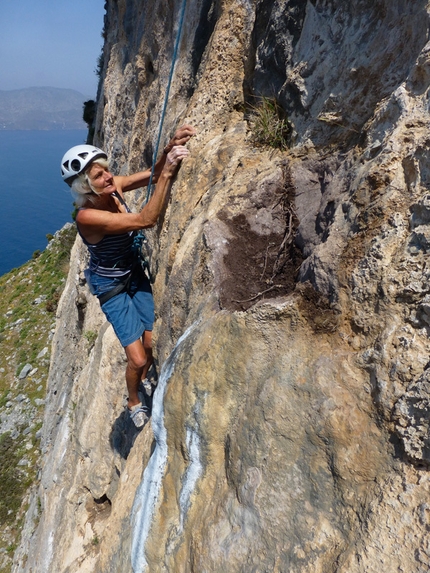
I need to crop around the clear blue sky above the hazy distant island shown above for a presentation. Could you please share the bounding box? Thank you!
[0,0,105,98]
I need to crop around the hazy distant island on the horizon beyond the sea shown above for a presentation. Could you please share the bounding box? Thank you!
[0,87,91,130]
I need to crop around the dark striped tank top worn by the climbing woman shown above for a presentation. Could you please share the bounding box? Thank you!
[76,193,135,278]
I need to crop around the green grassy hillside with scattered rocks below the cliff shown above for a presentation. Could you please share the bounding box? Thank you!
[0,224,76,573]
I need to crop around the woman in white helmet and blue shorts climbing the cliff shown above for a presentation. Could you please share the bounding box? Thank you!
[61,125,195,428]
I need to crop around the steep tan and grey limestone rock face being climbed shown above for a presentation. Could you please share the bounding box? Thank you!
[10,0,430,573]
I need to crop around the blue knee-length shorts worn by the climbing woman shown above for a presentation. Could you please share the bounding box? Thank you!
[91,272,154,347]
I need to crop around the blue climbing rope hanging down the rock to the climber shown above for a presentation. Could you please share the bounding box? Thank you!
[132,0,187,273]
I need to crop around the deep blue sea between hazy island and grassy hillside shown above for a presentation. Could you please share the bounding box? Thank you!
[0,129,87,276]
